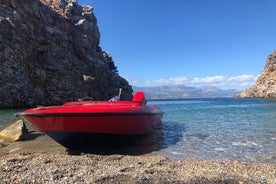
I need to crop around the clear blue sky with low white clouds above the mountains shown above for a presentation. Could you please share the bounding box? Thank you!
[78,0,276,89]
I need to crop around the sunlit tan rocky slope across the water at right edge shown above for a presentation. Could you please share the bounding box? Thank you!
[235,51,276,98]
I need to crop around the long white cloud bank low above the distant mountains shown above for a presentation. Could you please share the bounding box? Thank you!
[146,74,256,89]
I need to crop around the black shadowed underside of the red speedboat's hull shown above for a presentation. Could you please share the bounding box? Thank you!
[46,125,163,155]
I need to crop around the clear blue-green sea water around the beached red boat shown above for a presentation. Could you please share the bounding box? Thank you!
[0,98,276,163]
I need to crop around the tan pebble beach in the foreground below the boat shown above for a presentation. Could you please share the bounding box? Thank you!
[0,152,276,184]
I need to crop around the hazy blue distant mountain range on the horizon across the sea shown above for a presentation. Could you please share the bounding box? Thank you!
[133,85,241,99]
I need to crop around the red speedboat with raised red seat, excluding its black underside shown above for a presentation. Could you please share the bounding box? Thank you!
[17,92,163,145]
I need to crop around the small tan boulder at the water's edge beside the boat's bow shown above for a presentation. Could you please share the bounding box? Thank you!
[0,120,28,142]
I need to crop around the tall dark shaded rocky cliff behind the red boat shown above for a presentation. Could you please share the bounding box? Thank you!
[0,0,132,108]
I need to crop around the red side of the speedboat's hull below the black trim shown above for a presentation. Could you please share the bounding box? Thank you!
[24,109,162,134]
